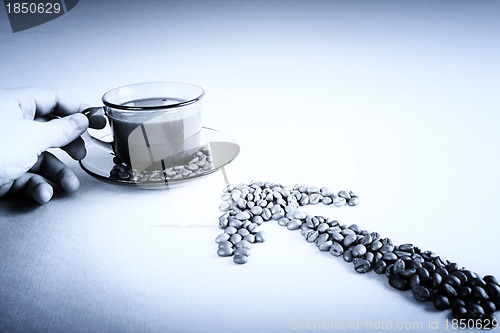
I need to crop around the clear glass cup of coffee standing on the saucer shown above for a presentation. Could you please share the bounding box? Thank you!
[88,82,204,171]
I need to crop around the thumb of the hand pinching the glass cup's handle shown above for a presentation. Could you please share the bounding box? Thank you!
[33,113,89,153]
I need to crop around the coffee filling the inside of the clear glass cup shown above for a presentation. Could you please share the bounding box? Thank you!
[109,98,201,170]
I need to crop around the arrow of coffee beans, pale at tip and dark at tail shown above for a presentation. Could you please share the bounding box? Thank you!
[215,182,500,322]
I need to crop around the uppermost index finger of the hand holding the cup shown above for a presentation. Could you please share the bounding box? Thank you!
[8,88,88,119]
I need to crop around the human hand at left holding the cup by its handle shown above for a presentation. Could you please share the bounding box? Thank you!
[0,88,105,204]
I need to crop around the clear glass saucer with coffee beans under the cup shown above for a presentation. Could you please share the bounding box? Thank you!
[80,127,240,189]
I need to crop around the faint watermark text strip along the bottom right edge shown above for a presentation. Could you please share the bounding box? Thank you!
[289,318,498,332]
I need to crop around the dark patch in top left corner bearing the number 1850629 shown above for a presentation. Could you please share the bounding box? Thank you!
[4,0,79,32]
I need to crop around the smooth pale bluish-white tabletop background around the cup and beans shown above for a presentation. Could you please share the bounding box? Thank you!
[0,1,500,332]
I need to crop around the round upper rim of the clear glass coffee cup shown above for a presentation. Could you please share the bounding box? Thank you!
[102,81,205,111]
